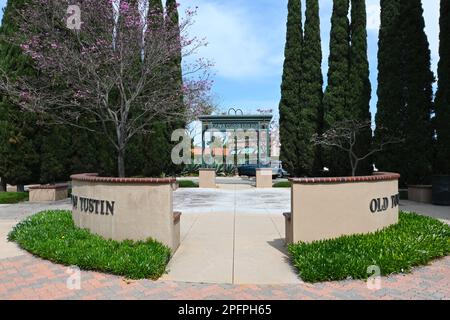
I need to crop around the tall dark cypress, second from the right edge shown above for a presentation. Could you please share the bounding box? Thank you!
[399,0,434,184]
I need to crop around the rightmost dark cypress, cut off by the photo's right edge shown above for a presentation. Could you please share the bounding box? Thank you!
[434,0,450,174]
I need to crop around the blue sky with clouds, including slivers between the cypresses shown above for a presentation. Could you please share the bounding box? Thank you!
[0,0,439,120]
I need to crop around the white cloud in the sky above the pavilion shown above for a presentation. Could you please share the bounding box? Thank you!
[179,0,284,80]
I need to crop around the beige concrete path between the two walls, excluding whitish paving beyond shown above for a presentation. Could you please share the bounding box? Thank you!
[163,212,300,284]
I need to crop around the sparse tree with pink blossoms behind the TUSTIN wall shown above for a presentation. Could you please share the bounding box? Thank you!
[0,0,211,177]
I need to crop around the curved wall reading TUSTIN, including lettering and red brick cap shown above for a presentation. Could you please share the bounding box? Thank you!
[71,174,181,253]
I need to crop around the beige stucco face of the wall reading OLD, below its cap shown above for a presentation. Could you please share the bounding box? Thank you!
[286,180,399,243]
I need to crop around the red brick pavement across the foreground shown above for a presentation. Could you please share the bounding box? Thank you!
[0,254,450,300]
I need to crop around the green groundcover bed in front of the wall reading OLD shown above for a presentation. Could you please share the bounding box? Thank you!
[289,212,450,282]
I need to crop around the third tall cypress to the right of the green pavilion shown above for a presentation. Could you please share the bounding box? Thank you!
[323,0,352,175]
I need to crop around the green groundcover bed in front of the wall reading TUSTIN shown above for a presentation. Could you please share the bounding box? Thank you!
[8,211,170,280]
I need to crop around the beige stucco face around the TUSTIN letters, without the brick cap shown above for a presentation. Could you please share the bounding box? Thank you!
[72,180,180,252]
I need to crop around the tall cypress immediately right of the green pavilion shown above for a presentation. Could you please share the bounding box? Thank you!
[279,0,303,175]
